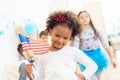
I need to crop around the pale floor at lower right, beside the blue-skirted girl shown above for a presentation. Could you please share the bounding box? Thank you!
[102,51,120,80]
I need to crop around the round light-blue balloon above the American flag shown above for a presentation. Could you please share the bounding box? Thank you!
[25,23,37,35]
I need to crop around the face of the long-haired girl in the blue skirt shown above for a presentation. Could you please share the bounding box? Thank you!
[79,12,90,25]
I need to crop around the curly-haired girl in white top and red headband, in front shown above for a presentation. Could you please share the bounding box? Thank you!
[24,11,97,80]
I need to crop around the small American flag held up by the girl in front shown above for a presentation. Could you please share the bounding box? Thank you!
[18,34,49,55]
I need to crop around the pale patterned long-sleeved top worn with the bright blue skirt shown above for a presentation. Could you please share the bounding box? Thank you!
[74,27,109,51]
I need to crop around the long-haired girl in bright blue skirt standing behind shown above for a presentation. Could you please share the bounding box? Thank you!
[73,11,116,80]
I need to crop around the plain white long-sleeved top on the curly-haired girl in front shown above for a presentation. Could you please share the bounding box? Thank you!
[41,46,97,80]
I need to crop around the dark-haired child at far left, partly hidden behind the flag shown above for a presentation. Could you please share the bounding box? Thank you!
[17,44,38,80]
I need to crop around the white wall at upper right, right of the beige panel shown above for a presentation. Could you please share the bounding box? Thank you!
[101,0,120,34]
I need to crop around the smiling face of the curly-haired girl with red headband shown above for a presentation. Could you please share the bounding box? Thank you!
[50,25,72,51]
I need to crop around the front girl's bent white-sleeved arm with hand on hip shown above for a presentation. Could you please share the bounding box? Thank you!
[73,48,98,80]
